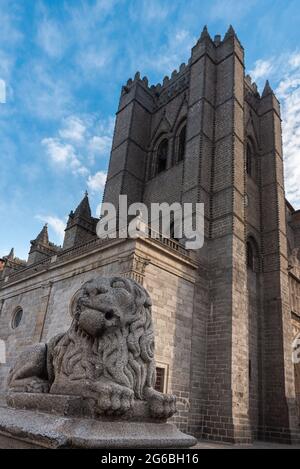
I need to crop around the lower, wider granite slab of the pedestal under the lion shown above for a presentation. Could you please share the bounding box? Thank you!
[0,407,197,449]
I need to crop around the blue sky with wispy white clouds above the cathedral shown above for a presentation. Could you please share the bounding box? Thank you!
[0,0,300,258]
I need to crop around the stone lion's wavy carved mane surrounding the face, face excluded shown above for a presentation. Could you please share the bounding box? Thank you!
[48,279,155,399]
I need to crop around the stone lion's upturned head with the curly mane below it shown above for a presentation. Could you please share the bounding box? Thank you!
[67,277,155,399]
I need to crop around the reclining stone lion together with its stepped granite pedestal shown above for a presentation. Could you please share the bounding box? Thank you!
[0,277,196,448]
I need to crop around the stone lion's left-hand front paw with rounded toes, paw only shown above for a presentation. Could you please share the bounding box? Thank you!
[97,386,134,415]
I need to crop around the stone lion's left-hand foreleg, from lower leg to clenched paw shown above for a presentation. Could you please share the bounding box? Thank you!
[88,380,134,415]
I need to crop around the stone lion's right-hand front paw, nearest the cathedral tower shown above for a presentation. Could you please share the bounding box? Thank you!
[145,387,176,419]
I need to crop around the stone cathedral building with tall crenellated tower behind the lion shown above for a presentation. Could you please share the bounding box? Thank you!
[0,27,300,443]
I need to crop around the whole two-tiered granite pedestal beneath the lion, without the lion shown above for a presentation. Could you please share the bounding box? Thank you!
[0,393,197,449]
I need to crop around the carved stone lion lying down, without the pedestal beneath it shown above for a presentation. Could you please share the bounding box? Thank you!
[8,277,176,419]
